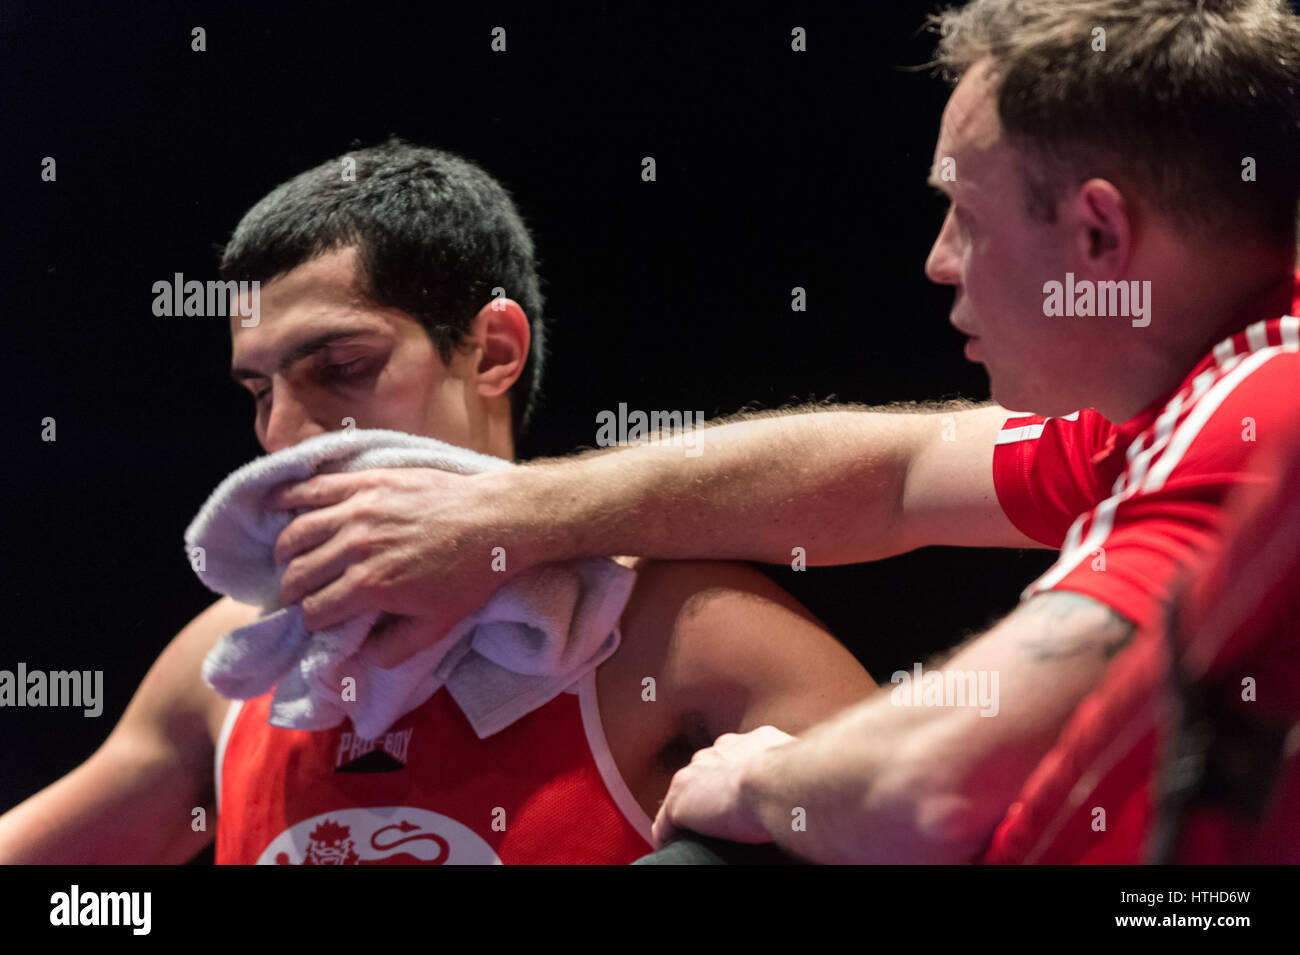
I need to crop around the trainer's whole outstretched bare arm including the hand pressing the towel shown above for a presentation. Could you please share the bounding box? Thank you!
[273,403,1039,667]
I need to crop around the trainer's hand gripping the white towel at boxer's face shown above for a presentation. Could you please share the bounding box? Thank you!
[268,468,530,668]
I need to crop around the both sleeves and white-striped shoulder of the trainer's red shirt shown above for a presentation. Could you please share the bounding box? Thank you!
[993,310,1300,626]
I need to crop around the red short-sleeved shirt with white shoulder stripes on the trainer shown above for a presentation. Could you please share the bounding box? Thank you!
[982,277,1300,864]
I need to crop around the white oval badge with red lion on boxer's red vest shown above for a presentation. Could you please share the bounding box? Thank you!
[257,806,502,865]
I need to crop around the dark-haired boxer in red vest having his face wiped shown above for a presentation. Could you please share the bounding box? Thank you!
[0,140,875,864]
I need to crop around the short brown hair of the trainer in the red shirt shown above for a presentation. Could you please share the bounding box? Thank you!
[930,0,1300,243]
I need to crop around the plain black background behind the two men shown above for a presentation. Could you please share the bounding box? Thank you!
[0,0,1052,857]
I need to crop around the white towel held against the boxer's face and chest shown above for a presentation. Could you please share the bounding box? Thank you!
[185,430,636,738]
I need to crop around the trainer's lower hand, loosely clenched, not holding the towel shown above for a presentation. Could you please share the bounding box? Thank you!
[650,726,794,847]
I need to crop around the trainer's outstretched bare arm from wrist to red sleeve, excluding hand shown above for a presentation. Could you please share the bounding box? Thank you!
[522,403,1041,565]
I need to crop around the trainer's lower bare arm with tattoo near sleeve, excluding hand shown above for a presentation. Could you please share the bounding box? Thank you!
[742,591,1134,863]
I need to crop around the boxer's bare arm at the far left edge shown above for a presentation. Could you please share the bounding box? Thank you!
[0,599,256,865]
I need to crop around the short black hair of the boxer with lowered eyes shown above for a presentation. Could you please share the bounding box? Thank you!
[220,138,546,440]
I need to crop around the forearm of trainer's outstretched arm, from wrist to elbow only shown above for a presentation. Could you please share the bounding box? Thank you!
[502,411,937,565]
